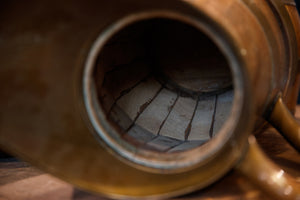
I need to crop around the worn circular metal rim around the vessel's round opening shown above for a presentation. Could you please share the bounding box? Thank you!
[83,11,245,173]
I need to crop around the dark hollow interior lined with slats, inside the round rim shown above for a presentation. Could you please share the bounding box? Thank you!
[94,18,234,152]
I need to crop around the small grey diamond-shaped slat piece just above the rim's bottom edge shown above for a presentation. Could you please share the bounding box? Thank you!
[145,135,182,151]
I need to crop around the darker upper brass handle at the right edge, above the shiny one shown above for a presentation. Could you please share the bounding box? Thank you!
[268,97,300,151]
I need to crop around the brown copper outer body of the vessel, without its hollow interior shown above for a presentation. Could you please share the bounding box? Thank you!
[0,0,300,199]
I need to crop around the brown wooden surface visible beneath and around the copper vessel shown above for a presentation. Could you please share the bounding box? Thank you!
[0,107,300,200]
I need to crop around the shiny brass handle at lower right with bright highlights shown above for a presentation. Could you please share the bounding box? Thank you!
[236,136,300,200]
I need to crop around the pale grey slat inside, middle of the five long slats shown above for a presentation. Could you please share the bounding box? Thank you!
[159,97,196,140]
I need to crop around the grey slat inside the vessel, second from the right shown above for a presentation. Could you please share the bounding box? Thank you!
[188,96,216,140]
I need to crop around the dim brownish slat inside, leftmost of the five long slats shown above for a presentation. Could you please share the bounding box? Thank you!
[116,78,161,120]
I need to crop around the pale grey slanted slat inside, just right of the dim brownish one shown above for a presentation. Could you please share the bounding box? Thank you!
[136,89,177,134]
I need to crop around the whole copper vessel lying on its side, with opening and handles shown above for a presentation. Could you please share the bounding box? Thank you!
[0,0,300,199]
